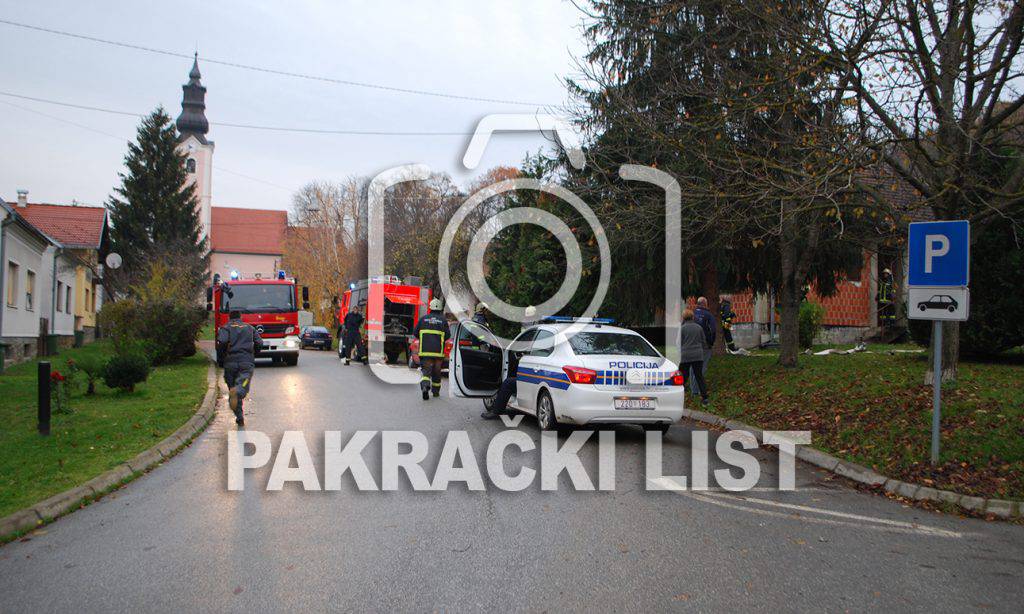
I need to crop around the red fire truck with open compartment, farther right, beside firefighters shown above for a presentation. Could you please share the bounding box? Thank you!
[338,275,431,362]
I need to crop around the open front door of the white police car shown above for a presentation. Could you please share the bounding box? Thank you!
[449,320,505,397]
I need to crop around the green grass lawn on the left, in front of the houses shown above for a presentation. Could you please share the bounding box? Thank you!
[0,341,207,517]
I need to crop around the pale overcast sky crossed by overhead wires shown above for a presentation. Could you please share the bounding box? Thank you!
[0,0,586,209]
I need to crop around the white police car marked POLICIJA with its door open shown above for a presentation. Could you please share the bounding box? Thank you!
[449,317,684,433]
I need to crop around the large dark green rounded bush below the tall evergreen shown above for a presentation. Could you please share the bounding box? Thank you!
[99,299,207,364]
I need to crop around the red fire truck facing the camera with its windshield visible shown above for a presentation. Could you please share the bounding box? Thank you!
[206,271,309,366]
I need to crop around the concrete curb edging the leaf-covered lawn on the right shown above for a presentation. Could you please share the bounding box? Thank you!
[683,407,1024,519]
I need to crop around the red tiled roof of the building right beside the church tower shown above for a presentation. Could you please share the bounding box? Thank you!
[210,207,288,256]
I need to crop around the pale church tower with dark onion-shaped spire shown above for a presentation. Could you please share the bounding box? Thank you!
[176,53,213,238]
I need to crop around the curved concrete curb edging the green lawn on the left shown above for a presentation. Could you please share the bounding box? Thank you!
[0,350,219,544]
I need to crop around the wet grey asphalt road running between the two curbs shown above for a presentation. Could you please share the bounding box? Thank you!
[0,343,1024,613]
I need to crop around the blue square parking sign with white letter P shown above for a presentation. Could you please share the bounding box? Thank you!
[907,220,971,287]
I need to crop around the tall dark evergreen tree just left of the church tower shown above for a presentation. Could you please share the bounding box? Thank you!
[106,106,210,293]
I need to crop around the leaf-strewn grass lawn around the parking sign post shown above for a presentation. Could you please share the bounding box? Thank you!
[708,346,1024,499]
